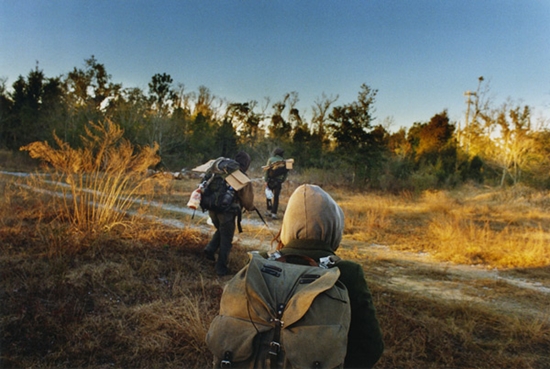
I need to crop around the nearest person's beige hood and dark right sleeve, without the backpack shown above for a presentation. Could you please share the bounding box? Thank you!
[278,184,384,368]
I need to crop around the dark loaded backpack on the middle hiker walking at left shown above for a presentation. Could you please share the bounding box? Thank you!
[200,158,239,212]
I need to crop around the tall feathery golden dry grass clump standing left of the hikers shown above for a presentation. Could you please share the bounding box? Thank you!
[21,120,168,232]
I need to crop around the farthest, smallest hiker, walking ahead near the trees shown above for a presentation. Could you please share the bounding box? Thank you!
[264,147,288,219]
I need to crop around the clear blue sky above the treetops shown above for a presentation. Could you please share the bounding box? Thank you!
[0,0,550,131]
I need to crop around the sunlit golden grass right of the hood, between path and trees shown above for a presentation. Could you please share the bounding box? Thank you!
[338,187,550,268]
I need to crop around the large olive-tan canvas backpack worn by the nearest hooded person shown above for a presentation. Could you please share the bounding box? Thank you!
[206,253,351,368]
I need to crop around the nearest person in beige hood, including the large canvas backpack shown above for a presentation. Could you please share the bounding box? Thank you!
[209,185,384,368]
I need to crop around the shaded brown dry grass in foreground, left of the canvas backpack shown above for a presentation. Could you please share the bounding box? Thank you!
[0,183,222,368]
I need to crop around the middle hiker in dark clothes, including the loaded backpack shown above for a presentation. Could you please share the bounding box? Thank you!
[201,151,256,277]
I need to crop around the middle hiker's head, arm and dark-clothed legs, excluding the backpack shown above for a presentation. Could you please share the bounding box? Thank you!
[204,151,256,277]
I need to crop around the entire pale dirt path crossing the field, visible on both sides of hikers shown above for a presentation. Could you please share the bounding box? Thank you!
[3,172,550,320]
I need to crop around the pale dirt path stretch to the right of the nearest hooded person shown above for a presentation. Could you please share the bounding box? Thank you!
[338,241,550,320]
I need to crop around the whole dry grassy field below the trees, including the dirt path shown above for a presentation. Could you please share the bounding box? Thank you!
[0,168,550,368]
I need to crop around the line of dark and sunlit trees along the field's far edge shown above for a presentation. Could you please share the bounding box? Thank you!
[0,56,550,191]
